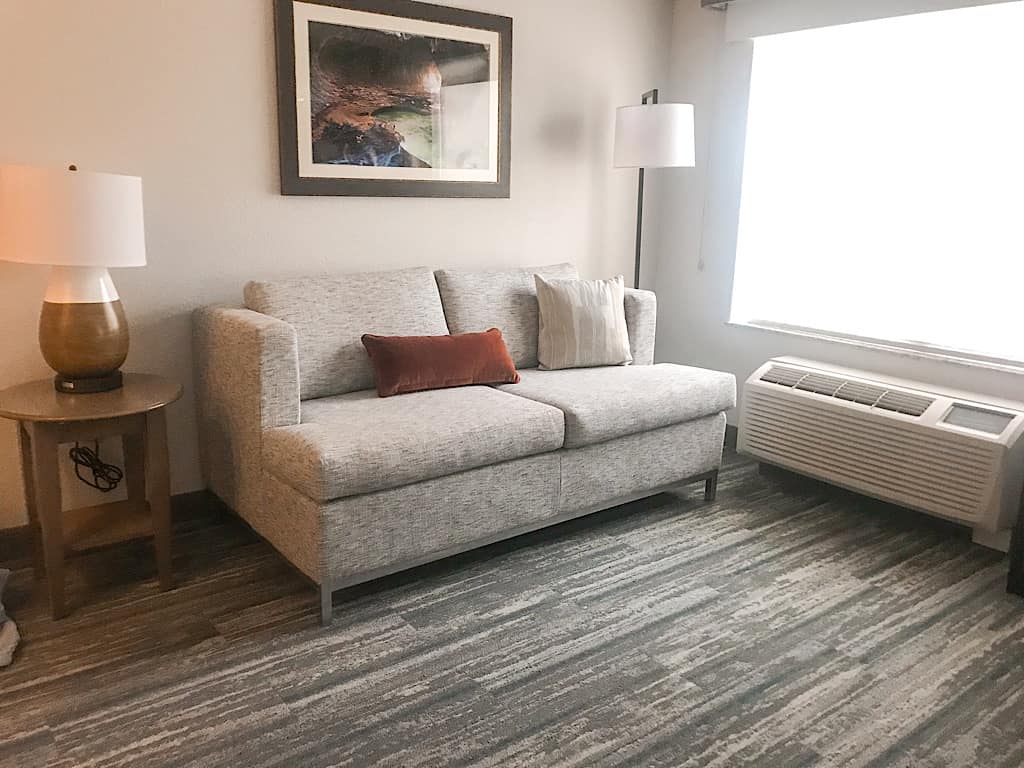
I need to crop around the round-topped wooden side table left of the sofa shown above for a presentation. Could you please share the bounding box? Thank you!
[0,374,181,618]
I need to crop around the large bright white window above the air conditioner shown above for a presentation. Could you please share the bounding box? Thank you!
[732,2,1024,361]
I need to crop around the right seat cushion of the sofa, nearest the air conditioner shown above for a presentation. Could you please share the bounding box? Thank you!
[499,364,736,447]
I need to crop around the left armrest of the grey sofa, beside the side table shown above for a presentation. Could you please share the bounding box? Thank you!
[193,307,301,517]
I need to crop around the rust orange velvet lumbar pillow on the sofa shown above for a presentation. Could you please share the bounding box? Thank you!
[362,328,519,397]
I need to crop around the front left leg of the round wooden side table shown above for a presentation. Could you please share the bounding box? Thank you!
[32,423,68,618]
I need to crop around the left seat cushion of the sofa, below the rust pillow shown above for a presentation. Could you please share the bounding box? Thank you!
[263,387,565,504]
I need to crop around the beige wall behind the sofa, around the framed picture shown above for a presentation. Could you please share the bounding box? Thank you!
[0,0,673,527]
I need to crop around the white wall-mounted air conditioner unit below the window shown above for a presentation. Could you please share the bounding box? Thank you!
[737,357,1024,550]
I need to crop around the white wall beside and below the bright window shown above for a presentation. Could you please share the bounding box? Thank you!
[655,0,1024,420]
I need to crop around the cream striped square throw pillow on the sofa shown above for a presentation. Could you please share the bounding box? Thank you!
[534,274,633,371]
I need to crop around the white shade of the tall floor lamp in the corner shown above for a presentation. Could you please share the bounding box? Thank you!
[615,104,695,168]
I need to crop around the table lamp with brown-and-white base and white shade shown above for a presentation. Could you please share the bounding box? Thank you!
[0,165,145,394]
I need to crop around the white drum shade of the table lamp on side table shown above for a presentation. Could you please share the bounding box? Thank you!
[0,165,145,267]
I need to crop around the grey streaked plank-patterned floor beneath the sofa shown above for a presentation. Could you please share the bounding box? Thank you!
[0,456,1024,768]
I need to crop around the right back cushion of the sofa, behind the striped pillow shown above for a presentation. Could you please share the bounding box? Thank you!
[435,264,580,368]
